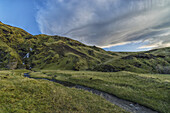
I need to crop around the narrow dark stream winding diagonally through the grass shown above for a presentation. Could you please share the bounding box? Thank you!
[24,73,158,113]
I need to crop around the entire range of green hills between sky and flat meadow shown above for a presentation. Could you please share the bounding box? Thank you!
[0,22,170,73]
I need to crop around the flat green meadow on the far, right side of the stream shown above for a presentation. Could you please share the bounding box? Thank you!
[31,70,170,113]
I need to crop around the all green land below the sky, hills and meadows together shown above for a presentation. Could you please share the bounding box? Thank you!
[0,22,170,113]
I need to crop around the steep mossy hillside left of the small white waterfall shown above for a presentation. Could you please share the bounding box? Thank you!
[0,22,31,69]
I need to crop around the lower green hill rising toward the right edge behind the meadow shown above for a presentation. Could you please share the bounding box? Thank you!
[94,48,170,74]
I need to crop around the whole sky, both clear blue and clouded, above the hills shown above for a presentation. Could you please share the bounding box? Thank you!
[0,0,170,51]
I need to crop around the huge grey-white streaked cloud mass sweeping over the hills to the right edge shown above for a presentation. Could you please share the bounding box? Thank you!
[37,0,170,48]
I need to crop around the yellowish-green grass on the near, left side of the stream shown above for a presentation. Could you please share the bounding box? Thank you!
[0,70,125,113]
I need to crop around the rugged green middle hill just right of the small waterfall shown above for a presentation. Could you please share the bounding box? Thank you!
[29,35,112,70]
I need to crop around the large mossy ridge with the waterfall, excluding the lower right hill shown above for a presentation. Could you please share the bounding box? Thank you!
[0,23,113,70]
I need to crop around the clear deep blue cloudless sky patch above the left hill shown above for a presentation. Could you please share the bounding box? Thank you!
[0,0,41,34]
